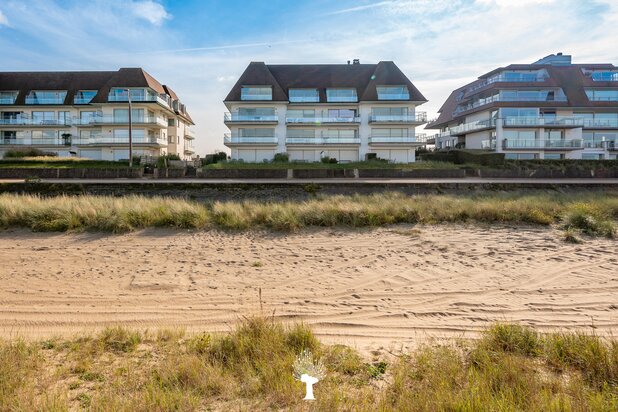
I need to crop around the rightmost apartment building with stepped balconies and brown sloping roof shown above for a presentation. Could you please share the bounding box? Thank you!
[427,53,618,159]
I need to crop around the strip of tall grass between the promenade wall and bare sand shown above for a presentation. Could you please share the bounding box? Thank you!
[0,192,618,237]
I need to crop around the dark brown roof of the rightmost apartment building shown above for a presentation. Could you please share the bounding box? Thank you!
[426,64,618,129]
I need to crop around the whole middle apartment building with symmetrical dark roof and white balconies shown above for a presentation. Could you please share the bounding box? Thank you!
[224,60,427,163]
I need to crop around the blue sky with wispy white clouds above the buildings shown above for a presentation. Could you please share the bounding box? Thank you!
[0,0,618,156]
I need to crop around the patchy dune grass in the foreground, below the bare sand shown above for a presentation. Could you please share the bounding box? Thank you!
[0,317,618,411]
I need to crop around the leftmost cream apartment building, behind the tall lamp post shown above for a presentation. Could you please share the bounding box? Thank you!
[0,68,195,160]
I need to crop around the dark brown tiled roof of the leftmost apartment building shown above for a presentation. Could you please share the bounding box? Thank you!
[0,68,191,120]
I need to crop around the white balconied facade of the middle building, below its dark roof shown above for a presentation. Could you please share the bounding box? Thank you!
[224,101,426,163]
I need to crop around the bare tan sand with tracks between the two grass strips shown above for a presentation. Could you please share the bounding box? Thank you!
[0,225,618,350]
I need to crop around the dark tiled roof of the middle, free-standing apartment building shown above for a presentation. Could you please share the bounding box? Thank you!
[225,61,427,102]
